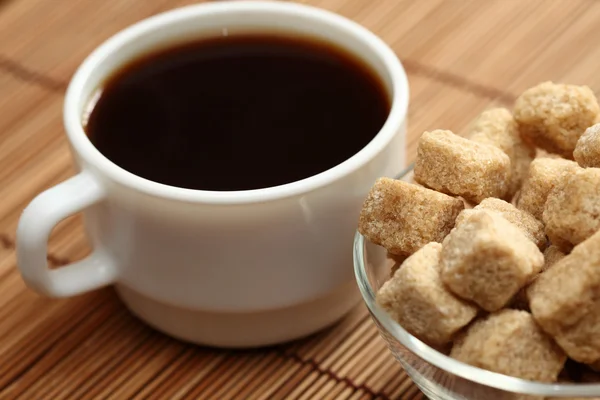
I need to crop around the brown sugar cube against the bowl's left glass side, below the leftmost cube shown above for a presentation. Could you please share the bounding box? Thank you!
[377,242,477,346]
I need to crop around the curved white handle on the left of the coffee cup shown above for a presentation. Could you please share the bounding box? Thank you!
[17,172,117,297]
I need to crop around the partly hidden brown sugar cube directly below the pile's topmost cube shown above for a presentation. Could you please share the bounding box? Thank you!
[517,158,579,221]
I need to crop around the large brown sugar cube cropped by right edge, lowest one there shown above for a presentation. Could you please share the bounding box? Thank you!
[527,227,600,364]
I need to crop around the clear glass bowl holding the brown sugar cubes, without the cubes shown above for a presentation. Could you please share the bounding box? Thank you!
[354,166,600,400]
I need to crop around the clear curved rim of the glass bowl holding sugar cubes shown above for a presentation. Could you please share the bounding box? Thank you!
[353,164,600,397]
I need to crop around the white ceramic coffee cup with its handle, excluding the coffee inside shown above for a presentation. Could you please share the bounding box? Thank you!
[17,1,408,347]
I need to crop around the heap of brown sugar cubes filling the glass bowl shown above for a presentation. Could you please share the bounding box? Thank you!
[359,82,600,388]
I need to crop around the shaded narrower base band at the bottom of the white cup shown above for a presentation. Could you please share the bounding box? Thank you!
[116,282,360,348]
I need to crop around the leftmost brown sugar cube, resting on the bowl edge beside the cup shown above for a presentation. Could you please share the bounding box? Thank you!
[358,178,464,255]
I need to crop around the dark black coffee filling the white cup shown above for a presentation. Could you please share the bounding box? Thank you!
[85,34,390,191]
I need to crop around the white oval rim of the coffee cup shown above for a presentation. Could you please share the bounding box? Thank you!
[63,0,409,204]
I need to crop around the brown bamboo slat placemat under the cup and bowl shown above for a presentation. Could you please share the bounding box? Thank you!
[0,0,600,400]
